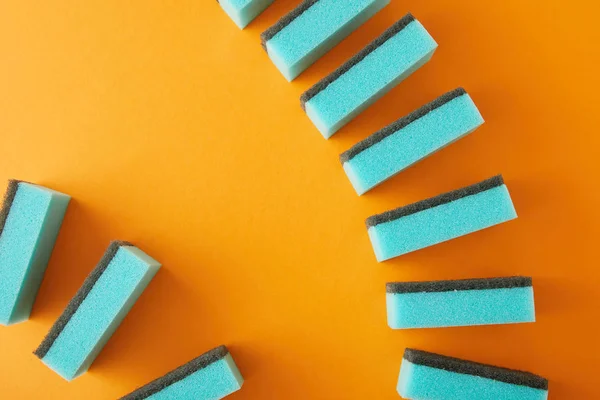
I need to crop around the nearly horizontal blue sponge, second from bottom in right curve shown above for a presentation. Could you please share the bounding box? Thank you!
[386,276,535,329]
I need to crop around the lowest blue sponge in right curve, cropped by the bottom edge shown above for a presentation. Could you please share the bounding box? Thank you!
[397,349,548,400]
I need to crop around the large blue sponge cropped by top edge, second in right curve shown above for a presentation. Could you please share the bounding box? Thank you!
[261,0,390,81]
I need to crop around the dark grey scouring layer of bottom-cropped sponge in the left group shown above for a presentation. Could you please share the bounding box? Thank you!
[120,346,229,400]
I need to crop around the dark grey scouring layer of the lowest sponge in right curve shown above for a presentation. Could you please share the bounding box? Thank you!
[404,349,548,390]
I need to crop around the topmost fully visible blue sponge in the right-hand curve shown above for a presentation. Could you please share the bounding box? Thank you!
[300,14,437,139]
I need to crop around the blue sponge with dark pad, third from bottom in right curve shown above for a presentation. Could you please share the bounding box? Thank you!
[366,175,517,261]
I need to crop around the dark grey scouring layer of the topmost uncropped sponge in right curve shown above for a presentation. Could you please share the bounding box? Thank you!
[300,13,415,110]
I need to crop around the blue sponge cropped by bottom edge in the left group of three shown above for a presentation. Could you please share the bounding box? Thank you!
[121,346,244,400]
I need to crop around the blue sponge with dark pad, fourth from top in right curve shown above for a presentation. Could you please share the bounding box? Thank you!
[340,88,483,195]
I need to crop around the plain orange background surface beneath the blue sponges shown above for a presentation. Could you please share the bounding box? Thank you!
[0,0,600,399]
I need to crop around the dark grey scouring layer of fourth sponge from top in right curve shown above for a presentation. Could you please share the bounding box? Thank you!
[340,88,467,164]
